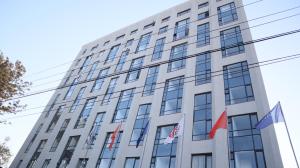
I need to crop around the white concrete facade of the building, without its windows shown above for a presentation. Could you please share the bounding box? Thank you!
[11,0,284,168]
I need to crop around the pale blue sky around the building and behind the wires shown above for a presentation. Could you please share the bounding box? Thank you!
[0,0,300,165]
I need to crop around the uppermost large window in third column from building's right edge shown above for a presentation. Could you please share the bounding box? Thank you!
[173,18,190,40]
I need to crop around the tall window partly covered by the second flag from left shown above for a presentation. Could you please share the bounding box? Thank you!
[129,103,151,145]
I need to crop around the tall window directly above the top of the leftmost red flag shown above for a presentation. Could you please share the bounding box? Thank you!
[112,89,134,123]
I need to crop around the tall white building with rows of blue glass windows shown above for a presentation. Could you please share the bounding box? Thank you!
[11,0,283,168]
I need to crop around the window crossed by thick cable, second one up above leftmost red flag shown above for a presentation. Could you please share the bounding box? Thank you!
[125,57,144,83]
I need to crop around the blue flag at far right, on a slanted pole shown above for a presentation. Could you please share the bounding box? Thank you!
[256,102,284,130]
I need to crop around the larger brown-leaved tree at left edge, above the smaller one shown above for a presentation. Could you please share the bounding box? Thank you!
[0,52,31,114]
